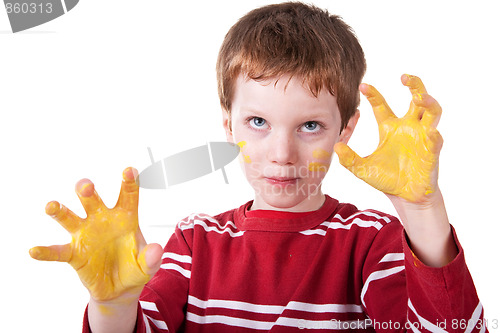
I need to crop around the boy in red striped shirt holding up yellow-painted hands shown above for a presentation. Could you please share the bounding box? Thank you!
[30,3,485,332]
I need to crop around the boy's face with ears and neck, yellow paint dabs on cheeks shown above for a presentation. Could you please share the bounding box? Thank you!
[223,75,359,211]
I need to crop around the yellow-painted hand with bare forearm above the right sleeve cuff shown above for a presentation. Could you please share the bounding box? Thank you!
[335,75,457,267]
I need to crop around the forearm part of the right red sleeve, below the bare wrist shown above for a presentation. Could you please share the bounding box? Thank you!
[403,227,487,332]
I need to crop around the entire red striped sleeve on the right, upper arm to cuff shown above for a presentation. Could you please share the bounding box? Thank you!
[361,221,487,332]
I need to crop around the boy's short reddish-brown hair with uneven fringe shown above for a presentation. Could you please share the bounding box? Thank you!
[217,2,366,131]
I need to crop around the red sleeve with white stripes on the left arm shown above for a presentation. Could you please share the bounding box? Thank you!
[83,222,192,333]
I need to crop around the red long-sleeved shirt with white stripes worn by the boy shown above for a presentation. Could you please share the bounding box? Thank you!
[84,196,484,333]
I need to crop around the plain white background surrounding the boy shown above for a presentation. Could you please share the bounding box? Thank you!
[0,0,500,332]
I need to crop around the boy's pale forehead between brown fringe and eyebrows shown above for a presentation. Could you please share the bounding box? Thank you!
[232,74,340,118]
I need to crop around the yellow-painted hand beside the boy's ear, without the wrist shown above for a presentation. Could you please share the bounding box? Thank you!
[335,75,443,202]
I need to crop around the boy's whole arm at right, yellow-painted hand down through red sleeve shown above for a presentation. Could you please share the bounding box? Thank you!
[335,75,484,332]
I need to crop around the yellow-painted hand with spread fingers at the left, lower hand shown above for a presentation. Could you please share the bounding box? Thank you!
[30,168,163,302]
